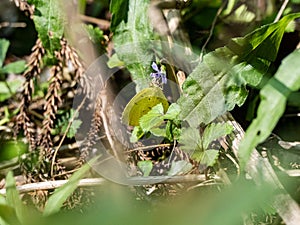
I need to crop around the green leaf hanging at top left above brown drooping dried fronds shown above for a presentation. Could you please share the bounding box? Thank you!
[32,0,64,57]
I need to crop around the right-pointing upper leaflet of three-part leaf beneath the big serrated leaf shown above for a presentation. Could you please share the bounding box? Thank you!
[202,123,233,149]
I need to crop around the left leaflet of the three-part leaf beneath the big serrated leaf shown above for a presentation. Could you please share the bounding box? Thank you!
[178,127,203,152]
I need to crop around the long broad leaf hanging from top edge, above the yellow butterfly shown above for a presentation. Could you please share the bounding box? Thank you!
[114,0,154,91]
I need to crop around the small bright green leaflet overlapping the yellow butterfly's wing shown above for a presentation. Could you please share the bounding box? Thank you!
[140,103,164,132]
